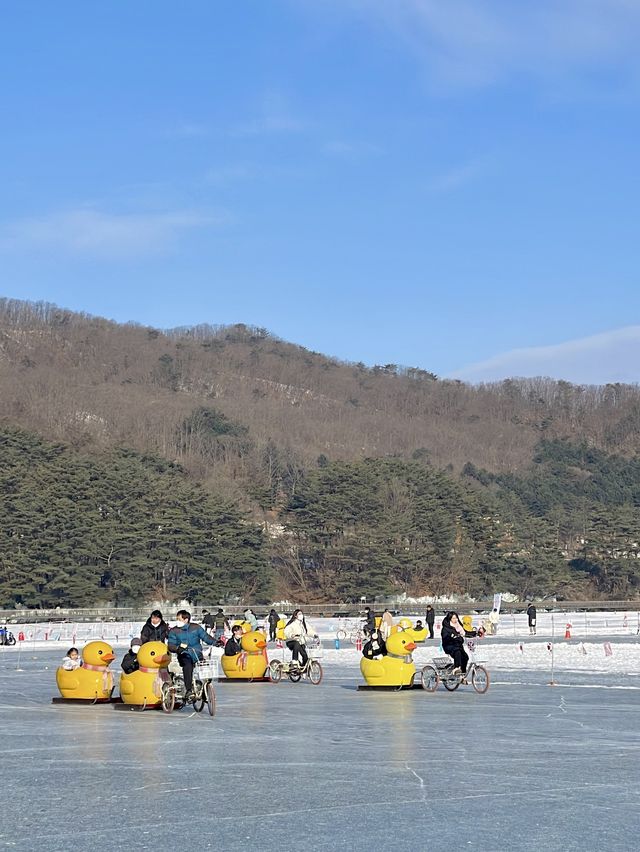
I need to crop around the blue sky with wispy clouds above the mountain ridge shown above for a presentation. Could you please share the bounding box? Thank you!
[0,0,640,383]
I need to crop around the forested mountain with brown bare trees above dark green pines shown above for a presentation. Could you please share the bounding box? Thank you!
[0,300,640,604]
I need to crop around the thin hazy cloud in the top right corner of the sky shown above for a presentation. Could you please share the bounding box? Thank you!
[332,0,640,88]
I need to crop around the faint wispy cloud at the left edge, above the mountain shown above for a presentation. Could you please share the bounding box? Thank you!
[0,207,226,258]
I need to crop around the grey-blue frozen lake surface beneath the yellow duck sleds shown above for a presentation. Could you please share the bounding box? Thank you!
[0,647,640,852]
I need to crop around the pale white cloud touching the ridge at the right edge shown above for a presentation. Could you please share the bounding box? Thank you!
[449,325,640,385]
